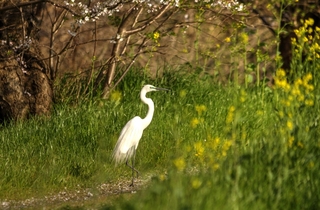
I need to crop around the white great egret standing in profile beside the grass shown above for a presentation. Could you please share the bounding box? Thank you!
[112,85,168,186]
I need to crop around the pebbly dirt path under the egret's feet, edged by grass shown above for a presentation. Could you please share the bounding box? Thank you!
[0,177,150,210]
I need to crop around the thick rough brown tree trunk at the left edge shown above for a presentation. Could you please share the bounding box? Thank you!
[0,1,53,123]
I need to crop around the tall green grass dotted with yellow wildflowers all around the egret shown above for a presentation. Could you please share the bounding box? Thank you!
[0,65,320,209]
